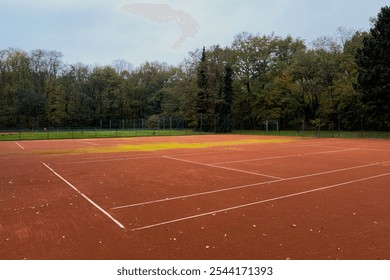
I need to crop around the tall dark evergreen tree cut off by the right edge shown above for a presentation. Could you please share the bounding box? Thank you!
[355,6,390,130]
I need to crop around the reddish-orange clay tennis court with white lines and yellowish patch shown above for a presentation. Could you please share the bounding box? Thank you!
[0,135,390,260]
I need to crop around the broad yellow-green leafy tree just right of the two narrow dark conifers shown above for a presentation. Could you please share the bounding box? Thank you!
[232,33,306,129]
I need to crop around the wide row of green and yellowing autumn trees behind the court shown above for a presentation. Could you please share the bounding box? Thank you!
[0,8,390,131]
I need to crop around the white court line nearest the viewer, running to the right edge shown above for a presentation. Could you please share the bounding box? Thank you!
[131,173,390,231]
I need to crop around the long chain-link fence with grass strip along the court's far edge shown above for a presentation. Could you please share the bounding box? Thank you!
[0,114,390,141]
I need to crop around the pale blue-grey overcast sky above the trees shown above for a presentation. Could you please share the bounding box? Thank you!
[0,0,389,66]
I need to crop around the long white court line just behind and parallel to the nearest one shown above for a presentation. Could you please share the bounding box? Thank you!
[111,161,390,210]
